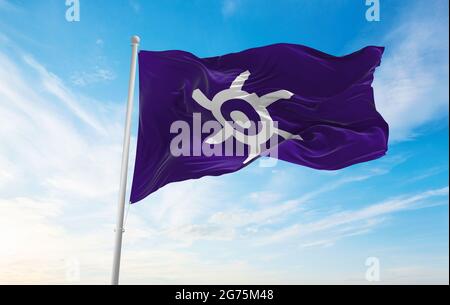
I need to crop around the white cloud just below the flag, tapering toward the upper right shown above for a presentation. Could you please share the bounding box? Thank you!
[137,152,406,245]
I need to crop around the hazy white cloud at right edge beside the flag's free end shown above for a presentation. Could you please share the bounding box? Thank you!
[374,1,449,142]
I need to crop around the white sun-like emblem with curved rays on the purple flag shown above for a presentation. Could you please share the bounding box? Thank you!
[192,71,301,164]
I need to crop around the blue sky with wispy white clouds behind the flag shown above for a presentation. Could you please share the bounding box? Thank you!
[0,0,449,284]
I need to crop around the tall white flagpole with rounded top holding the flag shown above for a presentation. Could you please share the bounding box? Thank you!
[111,36,140,285]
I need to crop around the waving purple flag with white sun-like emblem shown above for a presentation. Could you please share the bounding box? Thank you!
[131,44,389,203]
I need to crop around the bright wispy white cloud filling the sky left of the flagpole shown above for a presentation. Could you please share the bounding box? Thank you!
[0,40,126,283]
